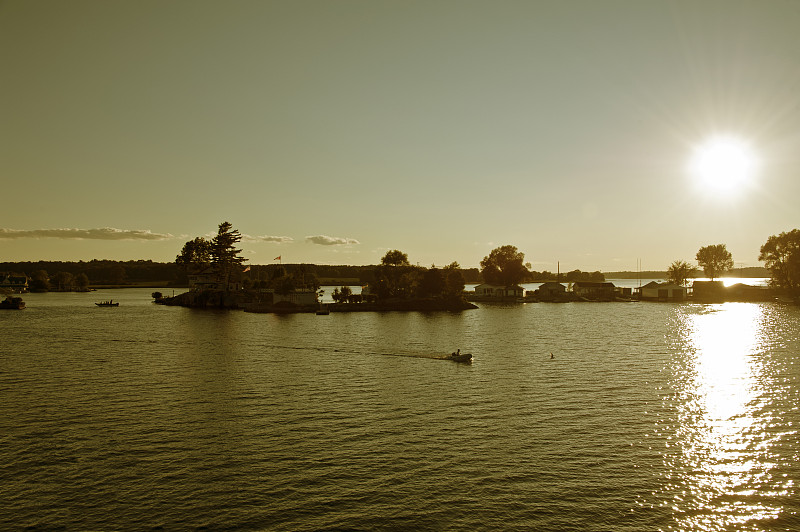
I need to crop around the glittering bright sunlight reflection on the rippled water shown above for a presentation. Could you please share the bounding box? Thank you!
[665,303,794,530]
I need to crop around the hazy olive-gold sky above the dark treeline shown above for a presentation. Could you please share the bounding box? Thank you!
[0,0,800,271]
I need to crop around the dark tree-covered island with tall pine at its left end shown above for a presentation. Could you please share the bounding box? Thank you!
[163,222,478,315]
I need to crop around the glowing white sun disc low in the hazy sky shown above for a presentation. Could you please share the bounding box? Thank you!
[689,135,758,194]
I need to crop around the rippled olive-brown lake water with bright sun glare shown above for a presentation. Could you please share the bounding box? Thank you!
[0,289,800,531]
